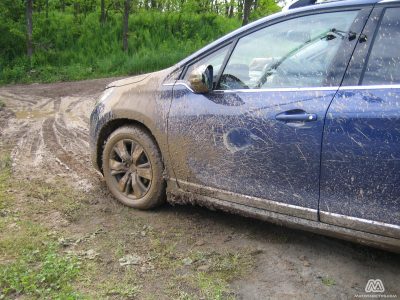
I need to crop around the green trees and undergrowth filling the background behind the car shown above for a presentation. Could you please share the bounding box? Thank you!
[0,0,279,84]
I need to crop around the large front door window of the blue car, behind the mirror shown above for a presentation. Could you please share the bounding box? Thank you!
[218,11,358,90]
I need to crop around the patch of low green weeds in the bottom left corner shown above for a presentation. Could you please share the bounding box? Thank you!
[0,246,80,299]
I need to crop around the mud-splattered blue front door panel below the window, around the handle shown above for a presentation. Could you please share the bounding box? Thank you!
[169,85,336,208]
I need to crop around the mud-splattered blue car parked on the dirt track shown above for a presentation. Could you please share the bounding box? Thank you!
[90,0,400,252]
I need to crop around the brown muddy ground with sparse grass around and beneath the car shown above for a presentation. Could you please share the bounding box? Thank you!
[0,79,400,299]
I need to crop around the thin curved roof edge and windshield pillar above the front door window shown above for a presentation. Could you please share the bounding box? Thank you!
[177,0,390,66]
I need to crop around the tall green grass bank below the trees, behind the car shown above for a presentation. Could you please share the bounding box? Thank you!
[0,11,240,84]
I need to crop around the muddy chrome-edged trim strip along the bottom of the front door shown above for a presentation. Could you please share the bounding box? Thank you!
[177,180,318,221]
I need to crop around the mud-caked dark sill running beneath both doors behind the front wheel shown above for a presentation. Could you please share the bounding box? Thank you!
[167,187,400,253]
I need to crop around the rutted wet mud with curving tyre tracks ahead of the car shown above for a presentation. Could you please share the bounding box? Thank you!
[0,81,111,186]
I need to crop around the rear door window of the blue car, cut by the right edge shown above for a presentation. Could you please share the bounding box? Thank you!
[362,8,400,85]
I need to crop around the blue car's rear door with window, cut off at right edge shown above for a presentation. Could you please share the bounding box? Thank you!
[320,2,400,238]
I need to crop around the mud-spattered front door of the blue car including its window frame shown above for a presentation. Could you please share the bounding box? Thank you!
[168,8,369,220]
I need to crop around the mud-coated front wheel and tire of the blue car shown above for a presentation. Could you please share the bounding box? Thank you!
[102,126,165,209]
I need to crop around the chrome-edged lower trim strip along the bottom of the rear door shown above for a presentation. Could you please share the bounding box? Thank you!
[320,211,400,239]
